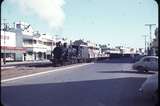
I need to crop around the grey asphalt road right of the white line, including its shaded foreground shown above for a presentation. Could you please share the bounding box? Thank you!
[1,62,154,106]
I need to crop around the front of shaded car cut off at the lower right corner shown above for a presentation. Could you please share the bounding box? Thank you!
[139,73,158,104]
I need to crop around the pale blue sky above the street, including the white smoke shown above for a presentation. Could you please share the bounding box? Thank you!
[1,0,158,48]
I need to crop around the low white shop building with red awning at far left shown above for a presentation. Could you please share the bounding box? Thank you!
[1,31,25,61]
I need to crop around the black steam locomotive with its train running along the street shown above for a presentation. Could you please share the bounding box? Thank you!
[50,44,101,66]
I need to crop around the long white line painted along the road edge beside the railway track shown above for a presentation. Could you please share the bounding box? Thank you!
[1,63,93,83]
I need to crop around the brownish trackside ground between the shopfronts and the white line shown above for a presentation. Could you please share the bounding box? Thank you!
[1,60,54,80]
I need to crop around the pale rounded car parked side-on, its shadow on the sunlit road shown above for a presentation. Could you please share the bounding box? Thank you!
[132,56,158,72]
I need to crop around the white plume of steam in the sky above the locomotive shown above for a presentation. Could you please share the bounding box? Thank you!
[12,0,65,28]
